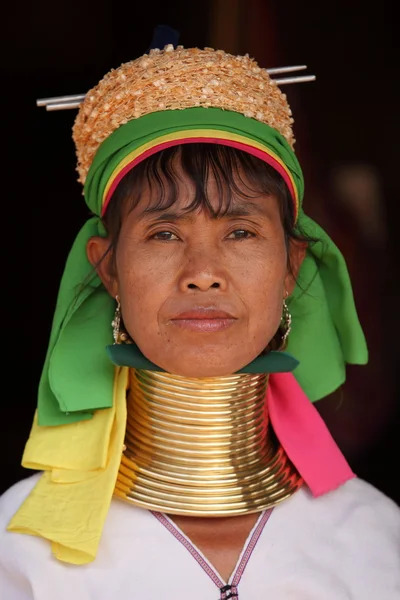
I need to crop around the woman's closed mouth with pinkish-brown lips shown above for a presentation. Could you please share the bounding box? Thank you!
[171,307,237,333]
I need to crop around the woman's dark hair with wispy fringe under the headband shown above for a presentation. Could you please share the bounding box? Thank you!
[103,143,315,276]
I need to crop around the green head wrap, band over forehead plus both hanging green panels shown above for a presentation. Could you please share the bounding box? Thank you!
[38,108,367,425]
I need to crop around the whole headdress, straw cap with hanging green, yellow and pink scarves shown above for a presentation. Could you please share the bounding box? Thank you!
[5,46,367,564]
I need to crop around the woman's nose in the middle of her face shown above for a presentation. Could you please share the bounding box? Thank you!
[179,254,227,292]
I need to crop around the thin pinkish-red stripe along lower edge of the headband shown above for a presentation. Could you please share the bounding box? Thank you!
[101,137,298,221]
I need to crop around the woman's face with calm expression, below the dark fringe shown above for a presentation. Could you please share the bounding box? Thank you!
[88,166,304,377]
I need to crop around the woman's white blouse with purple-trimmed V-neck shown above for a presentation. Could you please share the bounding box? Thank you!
[0,475,400,600]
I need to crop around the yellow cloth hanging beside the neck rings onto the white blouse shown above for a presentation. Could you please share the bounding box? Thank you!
[8,367,128,565]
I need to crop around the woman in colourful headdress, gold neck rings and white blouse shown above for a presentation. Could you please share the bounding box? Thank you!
[0,46,400,600]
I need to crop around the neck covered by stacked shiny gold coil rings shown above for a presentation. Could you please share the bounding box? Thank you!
[115,369,302,516]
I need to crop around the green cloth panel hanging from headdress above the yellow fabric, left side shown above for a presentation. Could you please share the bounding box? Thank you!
[38,217,114,425]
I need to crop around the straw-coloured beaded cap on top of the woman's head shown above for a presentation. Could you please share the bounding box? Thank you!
[73,45,294,184]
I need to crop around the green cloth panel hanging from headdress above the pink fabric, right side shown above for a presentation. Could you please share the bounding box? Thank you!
[287,212,368,401]
